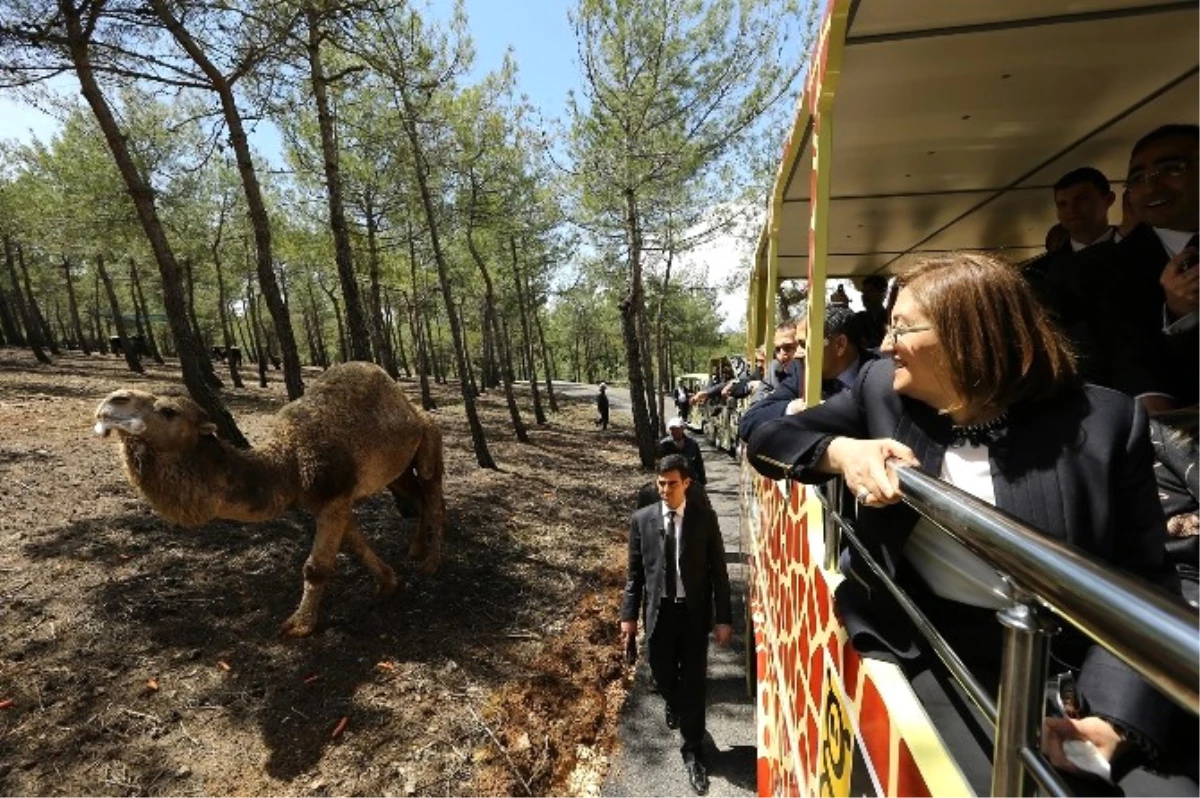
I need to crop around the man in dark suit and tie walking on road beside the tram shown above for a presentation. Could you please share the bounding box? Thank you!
[620,455,733,796]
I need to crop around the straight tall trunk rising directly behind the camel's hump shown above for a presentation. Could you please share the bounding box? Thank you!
[305,4,369,360]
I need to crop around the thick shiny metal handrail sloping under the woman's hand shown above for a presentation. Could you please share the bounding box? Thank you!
[895,464,1200,714]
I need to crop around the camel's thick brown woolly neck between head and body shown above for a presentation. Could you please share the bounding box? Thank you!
[124,437,298,527]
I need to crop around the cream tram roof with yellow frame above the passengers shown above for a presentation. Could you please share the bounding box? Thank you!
[758,0,1200,280]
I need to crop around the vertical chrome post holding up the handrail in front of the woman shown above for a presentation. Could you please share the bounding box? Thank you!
[991,602,1058,798]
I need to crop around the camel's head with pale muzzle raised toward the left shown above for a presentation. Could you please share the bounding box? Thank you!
[95,389,217,451]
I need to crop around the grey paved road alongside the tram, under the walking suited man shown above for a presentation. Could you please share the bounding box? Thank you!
[600,432,756,798]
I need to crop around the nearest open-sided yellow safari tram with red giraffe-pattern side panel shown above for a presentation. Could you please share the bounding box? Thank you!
[742,0,1200,798]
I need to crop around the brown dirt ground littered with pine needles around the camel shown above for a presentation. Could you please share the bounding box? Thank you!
[0,349,646,796]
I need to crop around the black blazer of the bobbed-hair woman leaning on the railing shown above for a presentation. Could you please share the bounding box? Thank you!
[748,360,1176,742]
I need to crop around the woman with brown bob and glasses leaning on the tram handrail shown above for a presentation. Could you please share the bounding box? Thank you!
[748,254,1176,775]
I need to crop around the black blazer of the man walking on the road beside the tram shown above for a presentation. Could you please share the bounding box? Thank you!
[620,502,733,640]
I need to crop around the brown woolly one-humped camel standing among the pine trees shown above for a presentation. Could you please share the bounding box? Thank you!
[95,362,445,637]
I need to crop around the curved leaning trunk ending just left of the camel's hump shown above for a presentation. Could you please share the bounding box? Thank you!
[150,0,304,400]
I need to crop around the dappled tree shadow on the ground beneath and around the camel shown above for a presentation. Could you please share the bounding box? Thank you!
[8,498,549,780]
